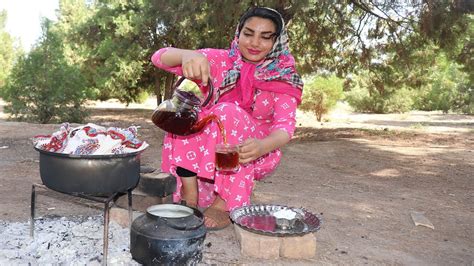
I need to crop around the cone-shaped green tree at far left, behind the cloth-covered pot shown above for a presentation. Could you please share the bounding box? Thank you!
[2,20,90,123]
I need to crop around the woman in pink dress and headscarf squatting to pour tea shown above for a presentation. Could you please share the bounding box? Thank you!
[152,7,303,230]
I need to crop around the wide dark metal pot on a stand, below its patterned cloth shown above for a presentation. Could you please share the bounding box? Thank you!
[35,147,140,196]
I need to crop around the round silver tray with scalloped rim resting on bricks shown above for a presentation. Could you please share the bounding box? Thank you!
[230,205,322,236]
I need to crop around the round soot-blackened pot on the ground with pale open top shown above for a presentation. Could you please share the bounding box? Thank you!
[130,204,206,265]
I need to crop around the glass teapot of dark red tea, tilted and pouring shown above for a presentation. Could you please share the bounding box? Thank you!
[151,77,214,136]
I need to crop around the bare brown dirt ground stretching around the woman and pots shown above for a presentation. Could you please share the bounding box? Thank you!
[0,98,474,265]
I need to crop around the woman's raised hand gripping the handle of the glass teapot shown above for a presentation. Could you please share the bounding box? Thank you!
[181,51,210,86]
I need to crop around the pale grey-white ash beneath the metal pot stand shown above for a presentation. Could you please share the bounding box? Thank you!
[0,216,140,265]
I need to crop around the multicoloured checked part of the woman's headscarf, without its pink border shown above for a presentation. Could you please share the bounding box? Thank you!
[220,8,303,101]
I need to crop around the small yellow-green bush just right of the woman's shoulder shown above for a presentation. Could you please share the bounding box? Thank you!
[299,75,344,121]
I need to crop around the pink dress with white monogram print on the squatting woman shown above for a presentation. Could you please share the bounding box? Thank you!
[152,48,297,211]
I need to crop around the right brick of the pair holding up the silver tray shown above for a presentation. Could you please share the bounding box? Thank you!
[280,233,316,259]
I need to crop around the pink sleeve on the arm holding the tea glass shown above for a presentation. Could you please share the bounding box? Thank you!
[270,93,298,138]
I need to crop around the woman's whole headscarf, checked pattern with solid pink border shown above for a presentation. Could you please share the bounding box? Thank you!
[219,9,303,108]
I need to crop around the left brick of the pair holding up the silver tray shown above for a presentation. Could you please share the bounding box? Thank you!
[234,225,280,259]
